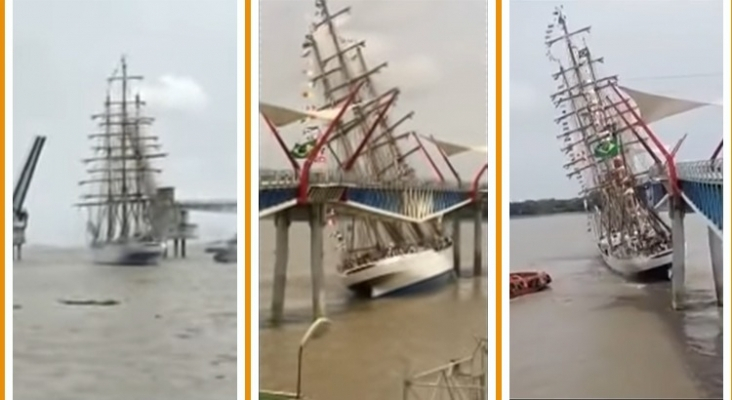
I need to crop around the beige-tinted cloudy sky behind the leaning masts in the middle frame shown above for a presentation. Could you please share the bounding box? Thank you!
[259,0,487,178]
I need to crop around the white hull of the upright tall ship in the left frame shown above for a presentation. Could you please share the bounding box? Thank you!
[92,242,165,265]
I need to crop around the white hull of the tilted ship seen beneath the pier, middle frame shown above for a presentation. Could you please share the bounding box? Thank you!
[341,246,453,298]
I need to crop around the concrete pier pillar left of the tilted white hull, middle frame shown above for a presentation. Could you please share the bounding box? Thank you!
[310,204,325,319]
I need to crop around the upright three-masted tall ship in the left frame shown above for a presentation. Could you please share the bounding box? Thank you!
[78,57,165,265]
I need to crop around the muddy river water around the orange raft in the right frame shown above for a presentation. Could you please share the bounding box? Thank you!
[510,215,723,398]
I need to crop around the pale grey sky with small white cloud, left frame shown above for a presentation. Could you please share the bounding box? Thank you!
[13,0,238,245]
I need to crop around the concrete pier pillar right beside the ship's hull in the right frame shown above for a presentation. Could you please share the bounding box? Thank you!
[670,202,686,310]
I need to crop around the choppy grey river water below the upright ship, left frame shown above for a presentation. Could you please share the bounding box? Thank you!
[13,247,236,400]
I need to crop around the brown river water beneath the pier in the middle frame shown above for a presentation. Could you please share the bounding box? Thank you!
[259,220,488,400]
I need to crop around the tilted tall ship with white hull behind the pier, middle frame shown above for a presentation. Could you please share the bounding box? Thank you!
[293,0,452,297]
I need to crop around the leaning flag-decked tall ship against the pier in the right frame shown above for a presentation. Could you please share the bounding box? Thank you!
[545,8,673,276]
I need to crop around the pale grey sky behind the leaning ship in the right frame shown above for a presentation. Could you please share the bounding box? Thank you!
[509,0,723,200]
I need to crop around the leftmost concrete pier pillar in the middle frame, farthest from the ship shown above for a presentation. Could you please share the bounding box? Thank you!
[272,210,290,323]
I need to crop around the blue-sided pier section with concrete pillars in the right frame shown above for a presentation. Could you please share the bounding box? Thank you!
[648,147,724,310]
